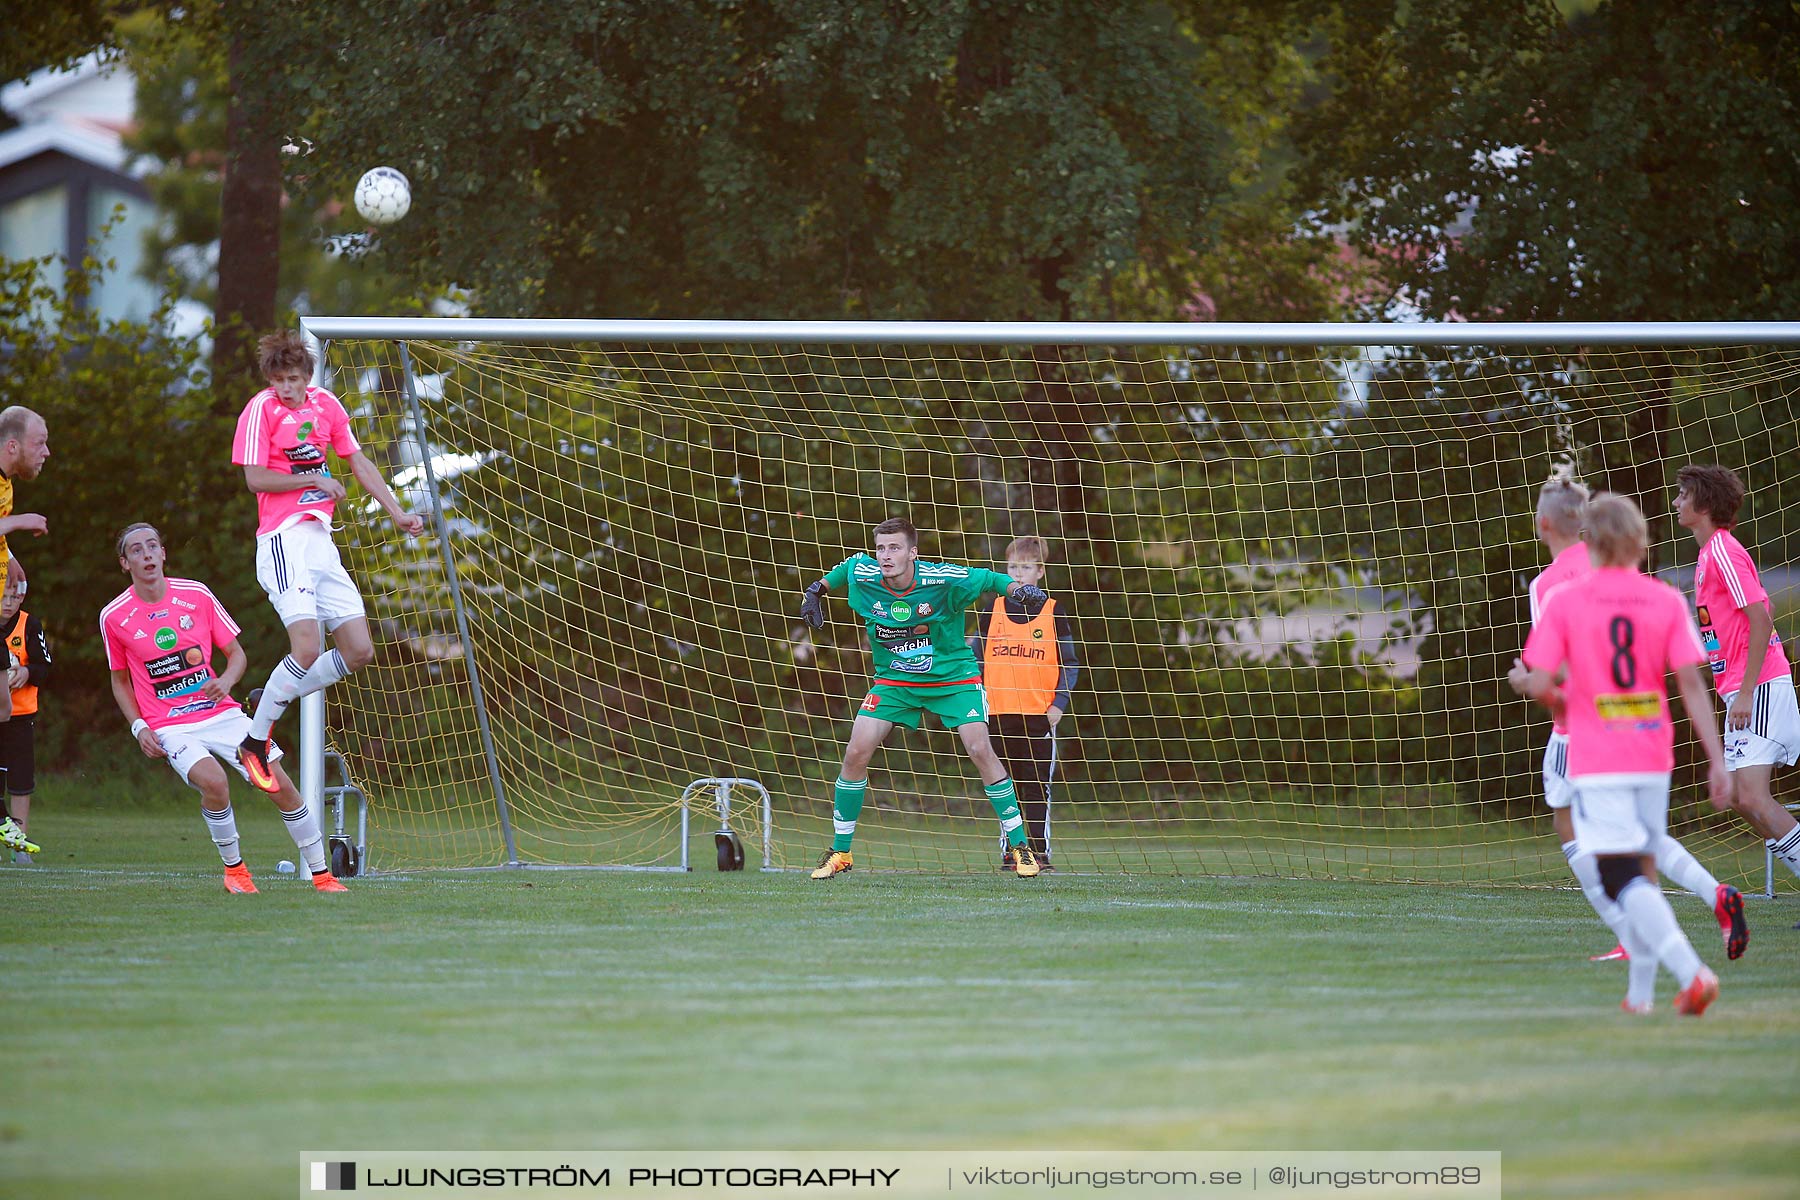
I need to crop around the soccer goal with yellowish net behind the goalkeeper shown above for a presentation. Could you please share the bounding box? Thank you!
[308,318,1800,885]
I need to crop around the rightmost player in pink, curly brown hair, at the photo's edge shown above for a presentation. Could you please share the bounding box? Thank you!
[1674,466,1800,888]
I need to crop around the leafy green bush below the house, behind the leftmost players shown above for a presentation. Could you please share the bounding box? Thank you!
[0,248,279,761]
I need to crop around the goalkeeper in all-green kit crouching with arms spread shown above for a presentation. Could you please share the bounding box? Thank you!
[799,516,1049,880]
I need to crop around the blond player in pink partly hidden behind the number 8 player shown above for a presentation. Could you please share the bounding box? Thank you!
[1507,477,1750,963]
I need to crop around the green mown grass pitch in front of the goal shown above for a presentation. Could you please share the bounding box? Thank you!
[0,774,1800,1198]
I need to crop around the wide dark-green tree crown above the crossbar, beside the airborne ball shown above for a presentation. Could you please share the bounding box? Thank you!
[266,0,1226,318]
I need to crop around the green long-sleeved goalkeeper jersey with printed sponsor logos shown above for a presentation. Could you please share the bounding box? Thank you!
[824,554,1012,684]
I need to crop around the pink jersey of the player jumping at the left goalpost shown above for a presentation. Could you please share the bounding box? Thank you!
[230,387,362,538]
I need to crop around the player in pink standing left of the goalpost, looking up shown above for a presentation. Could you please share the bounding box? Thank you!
[101,522,349,892]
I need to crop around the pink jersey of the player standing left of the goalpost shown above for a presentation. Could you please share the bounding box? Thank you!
[101,579,239,729]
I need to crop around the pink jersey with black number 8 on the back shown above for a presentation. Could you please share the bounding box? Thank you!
[1525,567,1706,779]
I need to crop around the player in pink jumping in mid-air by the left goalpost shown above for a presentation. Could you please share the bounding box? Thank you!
[232,331,425,792]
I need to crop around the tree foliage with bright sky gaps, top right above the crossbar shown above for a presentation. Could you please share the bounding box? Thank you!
[1300,0,1800,320]
